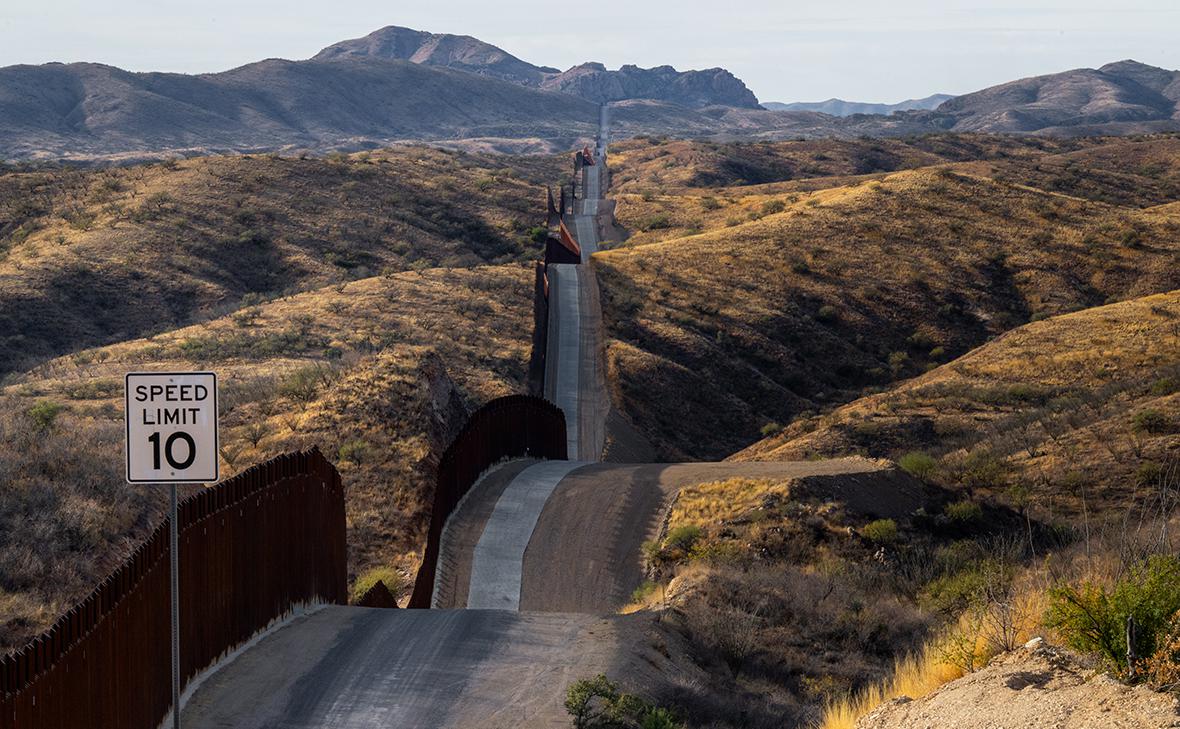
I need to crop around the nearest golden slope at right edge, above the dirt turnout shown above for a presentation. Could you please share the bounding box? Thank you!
[733,291,1180,515]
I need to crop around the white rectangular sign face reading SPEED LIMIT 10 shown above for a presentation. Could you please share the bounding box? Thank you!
[125,372,218,484]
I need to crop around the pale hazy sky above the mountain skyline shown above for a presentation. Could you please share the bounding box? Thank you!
[0,0,1180,101]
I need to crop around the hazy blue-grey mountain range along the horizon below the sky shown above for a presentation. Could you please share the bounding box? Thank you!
[0,26,1180,163]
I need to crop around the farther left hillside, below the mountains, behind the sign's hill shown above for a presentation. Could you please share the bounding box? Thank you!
[0,147,564,374]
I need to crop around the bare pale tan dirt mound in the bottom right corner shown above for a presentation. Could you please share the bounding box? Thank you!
[857,641,1180,729]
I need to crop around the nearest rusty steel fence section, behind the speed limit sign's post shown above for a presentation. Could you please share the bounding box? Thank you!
[0,449,348,729]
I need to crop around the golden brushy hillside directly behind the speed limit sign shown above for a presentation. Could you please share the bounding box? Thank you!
[0,264,533,652]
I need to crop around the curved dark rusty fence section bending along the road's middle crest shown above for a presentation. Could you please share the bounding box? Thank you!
[409,395,566,608]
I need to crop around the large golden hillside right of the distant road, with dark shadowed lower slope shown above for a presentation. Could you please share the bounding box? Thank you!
[596,139,1180,460]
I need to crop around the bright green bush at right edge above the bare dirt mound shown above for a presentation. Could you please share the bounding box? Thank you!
[1045,554,1180,671]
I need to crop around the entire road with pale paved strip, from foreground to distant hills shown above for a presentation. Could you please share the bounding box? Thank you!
[182,103,922,729]
